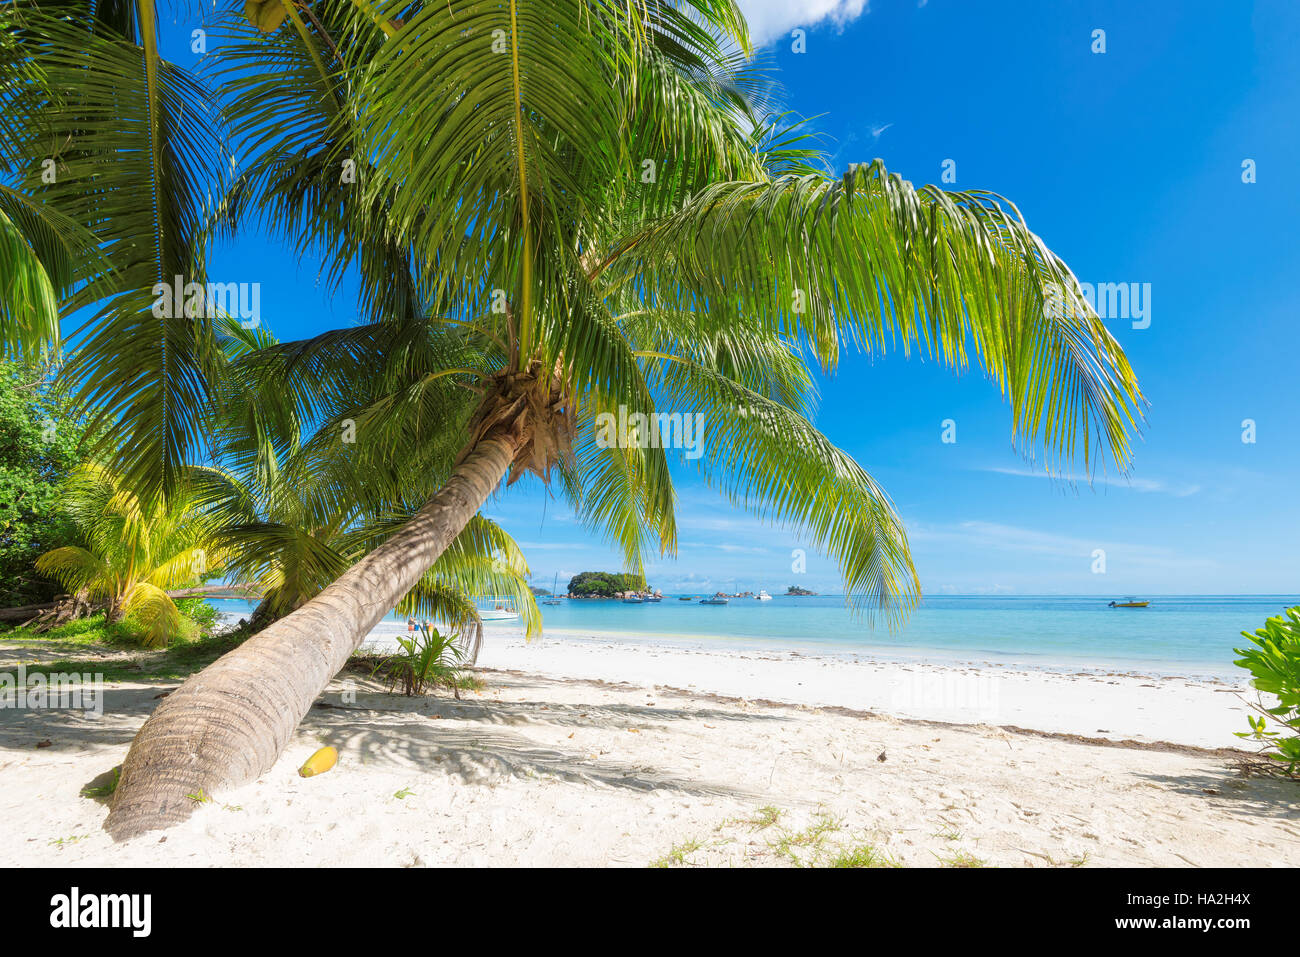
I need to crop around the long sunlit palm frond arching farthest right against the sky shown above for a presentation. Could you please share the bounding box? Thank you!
[607,161,1143,478]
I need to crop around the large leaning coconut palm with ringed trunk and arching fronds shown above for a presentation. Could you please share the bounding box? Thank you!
[0,0,1141,837]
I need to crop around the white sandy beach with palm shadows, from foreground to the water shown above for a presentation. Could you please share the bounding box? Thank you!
[0,635,1300,867]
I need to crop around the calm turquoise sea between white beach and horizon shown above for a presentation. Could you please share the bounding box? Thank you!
[205,596,1300,677]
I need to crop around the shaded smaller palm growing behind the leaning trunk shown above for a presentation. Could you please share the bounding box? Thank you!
[186,324,541,650]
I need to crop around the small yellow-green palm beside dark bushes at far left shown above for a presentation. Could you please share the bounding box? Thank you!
[36,464,221,648]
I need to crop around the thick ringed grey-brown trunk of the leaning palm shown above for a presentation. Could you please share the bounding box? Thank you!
[104,428,527,840]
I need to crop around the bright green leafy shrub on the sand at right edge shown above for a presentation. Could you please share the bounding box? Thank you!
[1235,606,1300,776]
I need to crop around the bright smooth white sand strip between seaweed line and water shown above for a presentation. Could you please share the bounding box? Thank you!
[379,628,1253,749]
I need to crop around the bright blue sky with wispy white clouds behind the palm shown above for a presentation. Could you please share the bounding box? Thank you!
[200,0,1300,594]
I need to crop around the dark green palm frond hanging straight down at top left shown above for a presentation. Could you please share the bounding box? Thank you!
[7,0,229,497]
